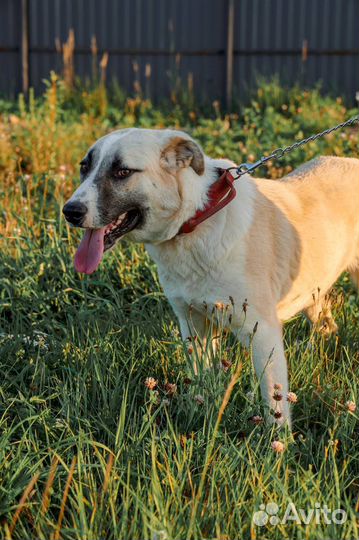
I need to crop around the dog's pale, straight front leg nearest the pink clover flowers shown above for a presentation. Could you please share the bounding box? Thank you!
[251,320,290,427]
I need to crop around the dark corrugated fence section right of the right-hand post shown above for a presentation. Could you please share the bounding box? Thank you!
[234,0,359,101]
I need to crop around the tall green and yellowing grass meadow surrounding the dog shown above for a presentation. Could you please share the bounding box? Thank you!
[0,76,359,540]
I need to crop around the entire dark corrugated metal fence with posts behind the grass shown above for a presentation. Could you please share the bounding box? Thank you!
[0,0,359,102]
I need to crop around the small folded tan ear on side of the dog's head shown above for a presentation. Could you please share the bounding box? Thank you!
[161,136,204,175]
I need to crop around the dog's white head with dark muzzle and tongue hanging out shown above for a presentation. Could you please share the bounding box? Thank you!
[63,129,207,274]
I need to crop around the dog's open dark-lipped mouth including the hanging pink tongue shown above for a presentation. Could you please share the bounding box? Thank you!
[74,208,142,274]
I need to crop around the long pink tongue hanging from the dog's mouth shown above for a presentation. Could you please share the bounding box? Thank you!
[74,227,105,274]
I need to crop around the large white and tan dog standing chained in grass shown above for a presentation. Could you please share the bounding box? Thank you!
[63,128,359,425]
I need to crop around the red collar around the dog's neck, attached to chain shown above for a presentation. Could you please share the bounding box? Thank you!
[178,169,236,234]
